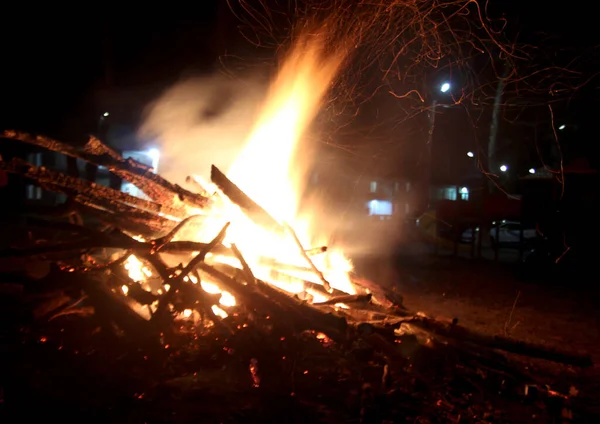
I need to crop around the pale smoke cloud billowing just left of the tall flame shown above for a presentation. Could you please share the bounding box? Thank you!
[138,75,267,184]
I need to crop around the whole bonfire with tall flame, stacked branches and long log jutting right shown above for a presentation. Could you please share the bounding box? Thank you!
[0,27,589,374]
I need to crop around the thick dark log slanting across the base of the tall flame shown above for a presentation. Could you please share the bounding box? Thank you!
[210,165,285,233]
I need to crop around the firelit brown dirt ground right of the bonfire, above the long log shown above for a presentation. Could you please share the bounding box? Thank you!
[356,253,600,363]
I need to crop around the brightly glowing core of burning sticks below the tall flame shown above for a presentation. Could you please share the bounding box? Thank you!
[115,161,391,330]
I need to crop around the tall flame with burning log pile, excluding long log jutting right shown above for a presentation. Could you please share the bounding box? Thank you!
[3,34,404,338]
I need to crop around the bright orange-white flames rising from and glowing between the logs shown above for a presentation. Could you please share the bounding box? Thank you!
[125,29,356,318]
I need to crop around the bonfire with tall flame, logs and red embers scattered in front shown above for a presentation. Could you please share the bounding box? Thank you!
[1,30,589,422]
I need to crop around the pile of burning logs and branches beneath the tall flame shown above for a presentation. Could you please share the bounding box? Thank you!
[2,132,404,348]
